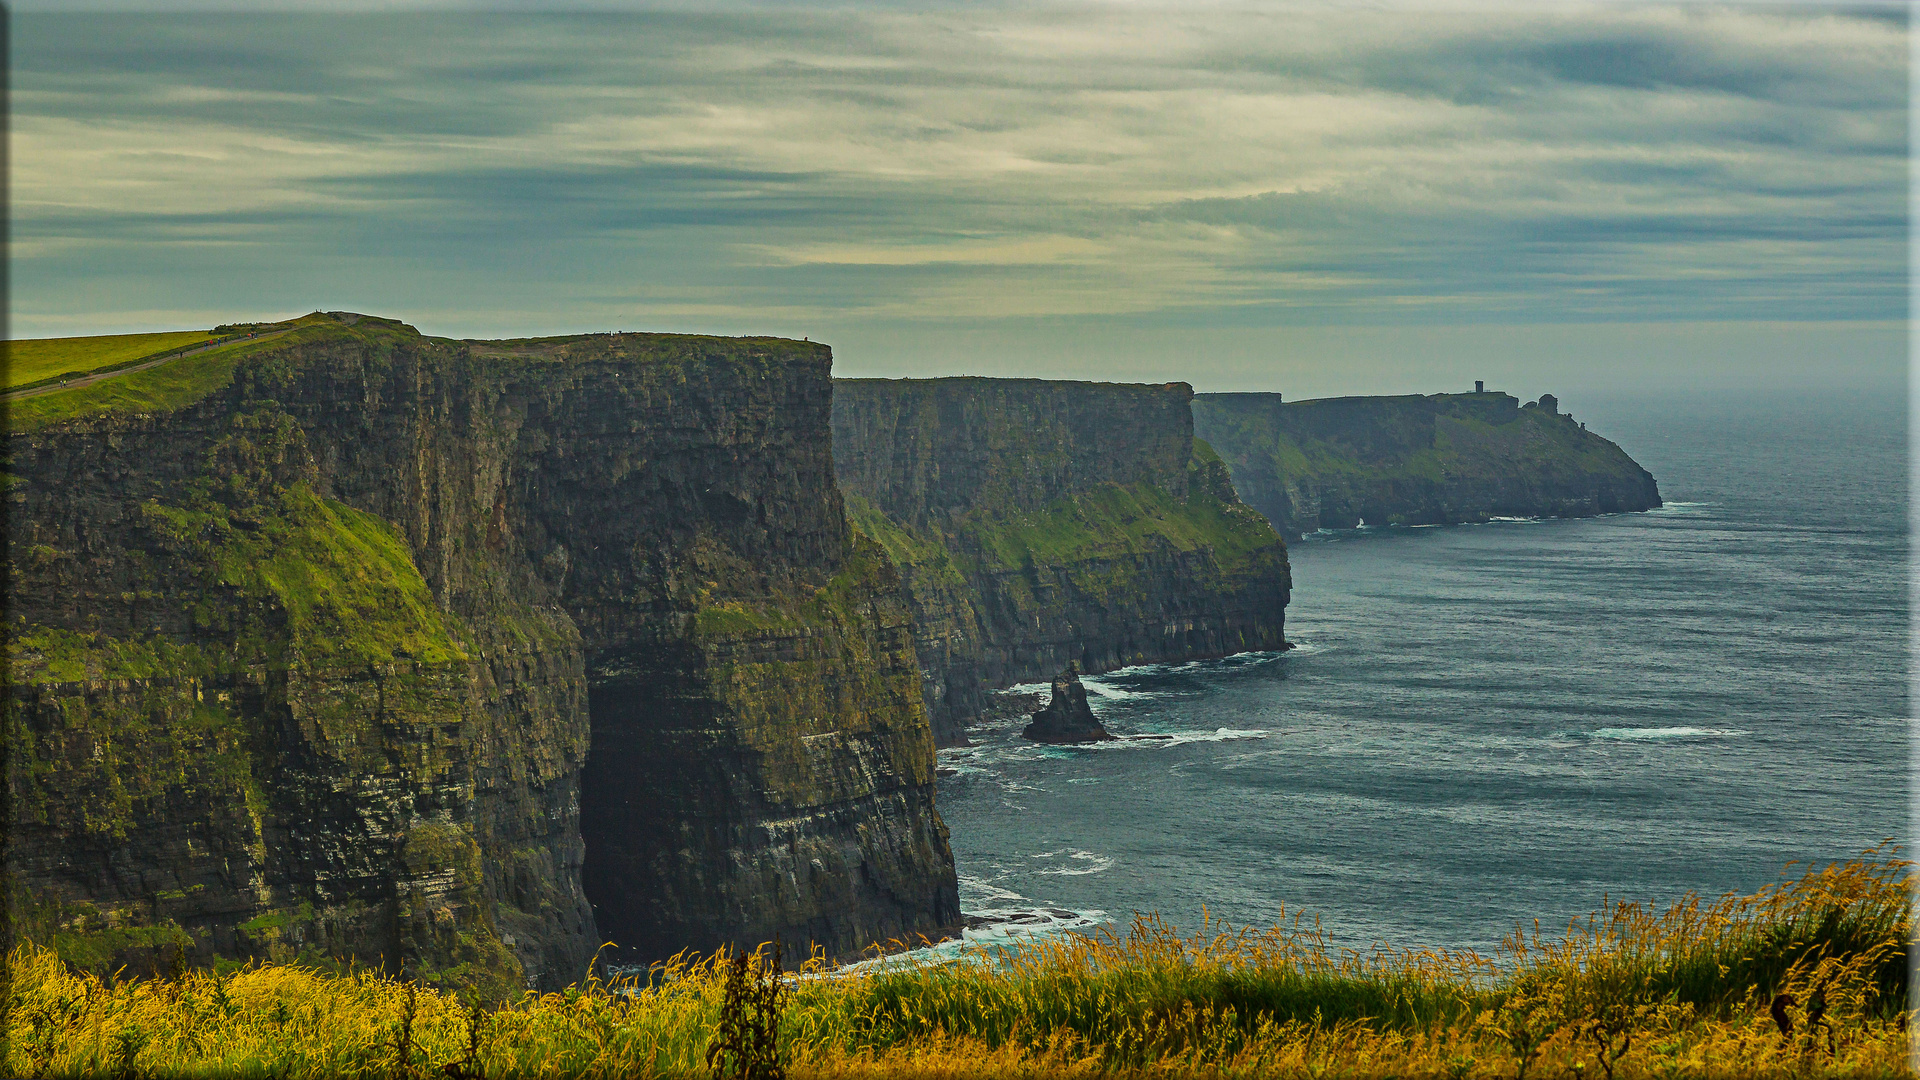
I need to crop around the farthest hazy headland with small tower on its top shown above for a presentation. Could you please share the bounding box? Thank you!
[1194,392,1661,536]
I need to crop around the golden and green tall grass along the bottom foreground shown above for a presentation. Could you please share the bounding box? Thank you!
[0,851,1912,1078]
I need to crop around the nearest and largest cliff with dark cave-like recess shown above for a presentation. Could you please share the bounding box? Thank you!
[8,317,958,986]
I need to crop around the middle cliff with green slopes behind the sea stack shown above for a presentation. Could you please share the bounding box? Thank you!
[833,379,1292,746]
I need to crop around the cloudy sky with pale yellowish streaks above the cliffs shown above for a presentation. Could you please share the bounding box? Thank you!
[10,0,1908,398]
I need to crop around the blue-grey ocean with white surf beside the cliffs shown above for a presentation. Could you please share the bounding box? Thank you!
[939,396,1910,953]
